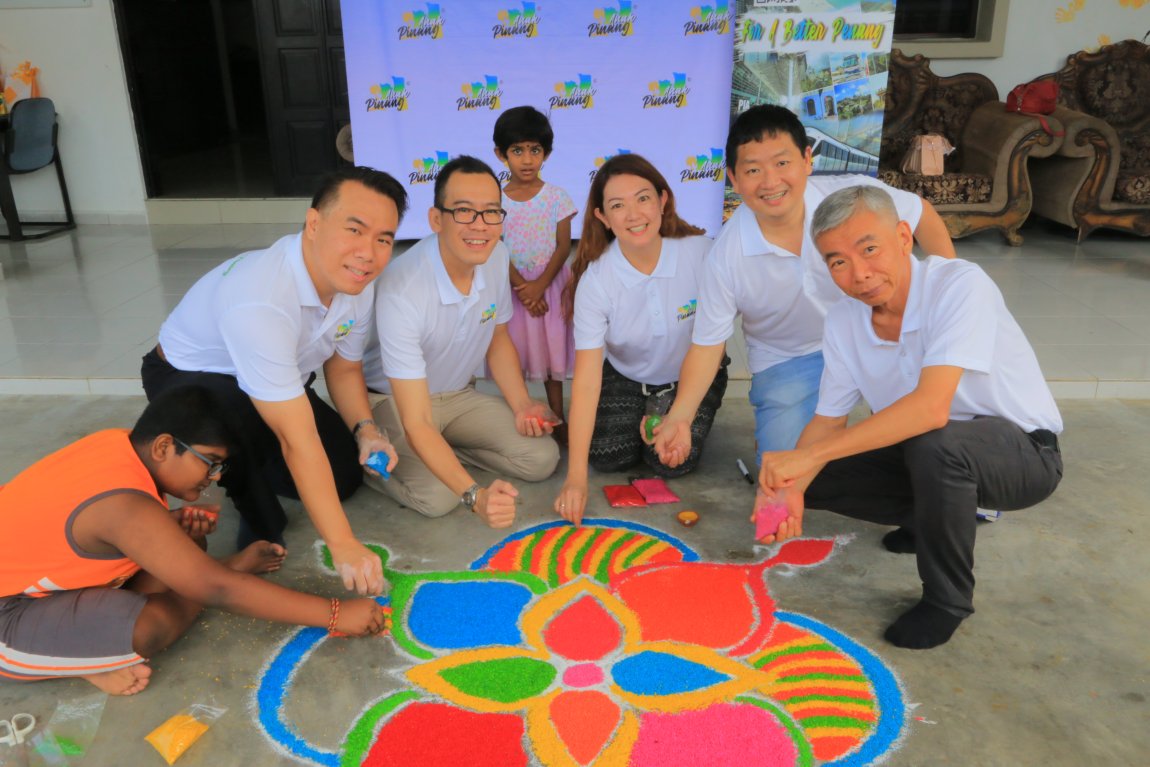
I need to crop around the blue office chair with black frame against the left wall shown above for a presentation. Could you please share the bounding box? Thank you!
[0,99,76,243]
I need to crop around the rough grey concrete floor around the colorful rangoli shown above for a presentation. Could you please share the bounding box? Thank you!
[0,396,1150,767]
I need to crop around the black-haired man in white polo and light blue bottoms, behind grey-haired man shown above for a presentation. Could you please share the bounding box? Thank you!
[656,105,955,466]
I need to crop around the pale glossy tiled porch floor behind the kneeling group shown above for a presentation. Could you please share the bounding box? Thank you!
[0,216,1150,399]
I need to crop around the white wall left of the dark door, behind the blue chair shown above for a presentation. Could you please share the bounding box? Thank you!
[0,0,146,223]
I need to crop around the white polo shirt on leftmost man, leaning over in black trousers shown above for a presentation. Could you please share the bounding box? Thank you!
[160,233,371,402]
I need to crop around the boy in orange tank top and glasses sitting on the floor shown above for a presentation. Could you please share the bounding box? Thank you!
[0,386,384,695]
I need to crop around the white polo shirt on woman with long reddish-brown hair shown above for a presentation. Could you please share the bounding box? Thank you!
[575,237,711,385]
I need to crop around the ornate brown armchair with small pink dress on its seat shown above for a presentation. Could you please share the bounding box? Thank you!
[879,48,1061,245]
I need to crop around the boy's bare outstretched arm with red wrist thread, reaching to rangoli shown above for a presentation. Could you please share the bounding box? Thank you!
[82,493,384,635]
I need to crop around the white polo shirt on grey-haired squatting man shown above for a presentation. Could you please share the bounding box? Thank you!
[815,255,1063,434]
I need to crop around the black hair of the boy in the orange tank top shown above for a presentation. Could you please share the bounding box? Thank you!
[128,385,236,454]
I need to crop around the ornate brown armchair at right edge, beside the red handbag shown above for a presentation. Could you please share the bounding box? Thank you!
[1030,40,1150,243]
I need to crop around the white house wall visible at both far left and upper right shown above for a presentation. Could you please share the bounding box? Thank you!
[0,0,1150,223]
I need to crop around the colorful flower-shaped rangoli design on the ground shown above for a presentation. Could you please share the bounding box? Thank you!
[255,520,905,767]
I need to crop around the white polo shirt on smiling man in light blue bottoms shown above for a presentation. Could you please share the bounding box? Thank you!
[693,175,922,374]
